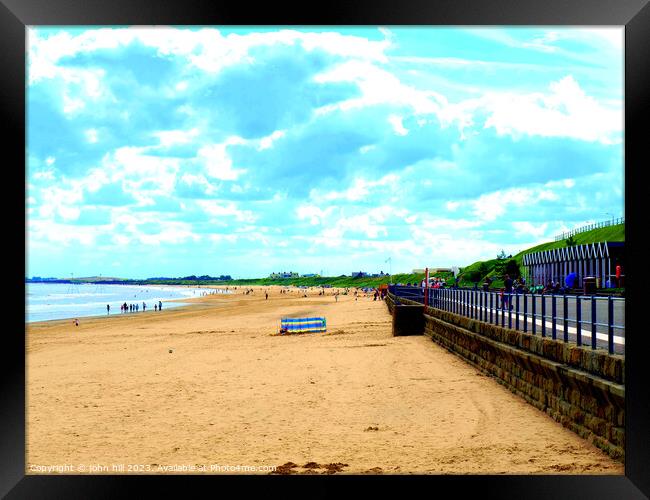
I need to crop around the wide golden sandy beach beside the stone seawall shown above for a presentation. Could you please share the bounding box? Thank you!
[26,287,624,475]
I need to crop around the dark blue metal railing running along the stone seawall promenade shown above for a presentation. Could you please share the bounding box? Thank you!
[389,285,625,354]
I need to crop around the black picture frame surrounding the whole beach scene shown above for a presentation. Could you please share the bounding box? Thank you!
[5,0,650,500]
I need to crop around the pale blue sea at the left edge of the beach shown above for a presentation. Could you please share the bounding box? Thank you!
[25,283,230,323]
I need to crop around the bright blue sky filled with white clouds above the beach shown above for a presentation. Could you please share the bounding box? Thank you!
[26,26,624,278]
